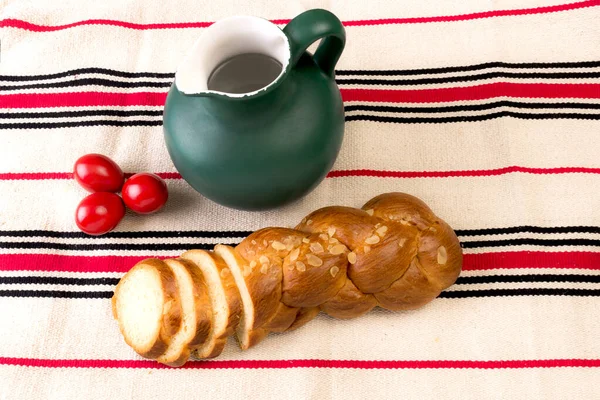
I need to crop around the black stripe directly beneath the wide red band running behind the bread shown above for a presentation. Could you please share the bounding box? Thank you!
[0,274,600,286]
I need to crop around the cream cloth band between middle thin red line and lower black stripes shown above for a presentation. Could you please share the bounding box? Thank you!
[0,174,600,231]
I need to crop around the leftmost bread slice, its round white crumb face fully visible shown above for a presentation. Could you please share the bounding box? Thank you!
[112,259,182,359]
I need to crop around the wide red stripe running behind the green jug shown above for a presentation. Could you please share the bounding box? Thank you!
[0,82,600,108]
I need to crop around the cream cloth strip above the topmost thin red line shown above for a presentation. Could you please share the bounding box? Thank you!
[4,0,577,25]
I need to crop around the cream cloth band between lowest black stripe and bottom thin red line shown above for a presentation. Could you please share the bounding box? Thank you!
[0,296,600,360]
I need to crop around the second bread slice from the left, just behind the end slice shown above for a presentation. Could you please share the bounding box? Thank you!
[156,259,212,367]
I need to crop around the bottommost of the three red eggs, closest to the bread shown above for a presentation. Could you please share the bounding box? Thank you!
[75,192,125,235]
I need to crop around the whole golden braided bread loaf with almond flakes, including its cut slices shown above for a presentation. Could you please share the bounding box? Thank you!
[112,193,462,366]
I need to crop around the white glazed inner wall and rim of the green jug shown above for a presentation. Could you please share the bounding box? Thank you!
[175,17,290,97]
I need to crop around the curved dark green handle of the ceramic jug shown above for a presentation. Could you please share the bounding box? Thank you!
[283,9,346,77]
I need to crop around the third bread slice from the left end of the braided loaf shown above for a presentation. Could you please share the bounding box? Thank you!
[181,250,242,358]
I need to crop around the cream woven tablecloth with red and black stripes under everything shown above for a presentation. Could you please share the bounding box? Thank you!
[0,0,600,400]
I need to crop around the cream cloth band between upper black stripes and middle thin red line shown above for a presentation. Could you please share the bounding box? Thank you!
[0,118,600,177]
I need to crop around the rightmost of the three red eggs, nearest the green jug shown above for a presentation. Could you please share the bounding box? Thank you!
[121,172,169,214]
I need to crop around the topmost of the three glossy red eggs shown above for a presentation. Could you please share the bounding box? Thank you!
[73,154,124,192]
